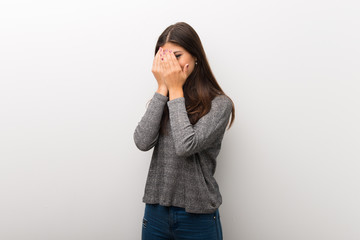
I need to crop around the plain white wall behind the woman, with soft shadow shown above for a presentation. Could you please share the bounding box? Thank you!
[0,0,360,240]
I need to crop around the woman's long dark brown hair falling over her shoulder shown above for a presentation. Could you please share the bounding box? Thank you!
[155,22,235,134]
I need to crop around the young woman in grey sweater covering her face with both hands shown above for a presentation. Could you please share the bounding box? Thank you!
[134,22,234,240]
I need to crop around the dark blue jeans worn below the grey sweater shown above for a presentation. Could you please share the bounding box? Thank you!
[142,204,223,240]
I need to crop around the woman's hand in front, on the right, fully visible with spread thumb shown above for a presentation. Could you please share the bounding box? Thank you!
[160,50,189,100]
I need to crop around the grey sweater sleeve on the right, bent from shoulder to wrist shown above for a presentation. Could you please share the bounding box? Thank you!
[167,95,232,156]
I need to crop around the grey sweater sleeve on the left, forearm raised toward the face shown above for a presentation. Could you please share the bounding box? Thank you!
[134,92,168,151]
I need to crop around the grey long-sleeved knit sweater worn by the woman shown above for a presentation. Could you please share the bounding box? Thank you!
[134,92,232,213]
